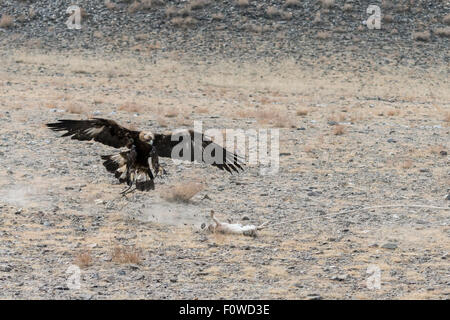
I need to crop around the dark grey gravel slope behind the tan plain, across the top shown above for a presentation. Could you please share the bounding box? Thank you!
[0,0,450,66]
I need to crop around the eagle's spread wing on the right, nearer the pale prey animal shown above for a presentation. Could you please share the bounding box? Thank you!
[153,130,244,173]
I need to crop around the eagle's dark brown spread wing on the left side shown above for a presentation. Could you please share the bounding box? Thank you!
[47,118,139,148]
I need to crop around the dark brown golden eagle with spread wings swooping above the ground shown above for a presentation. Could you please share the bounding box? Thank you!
[47,118,244,194]
